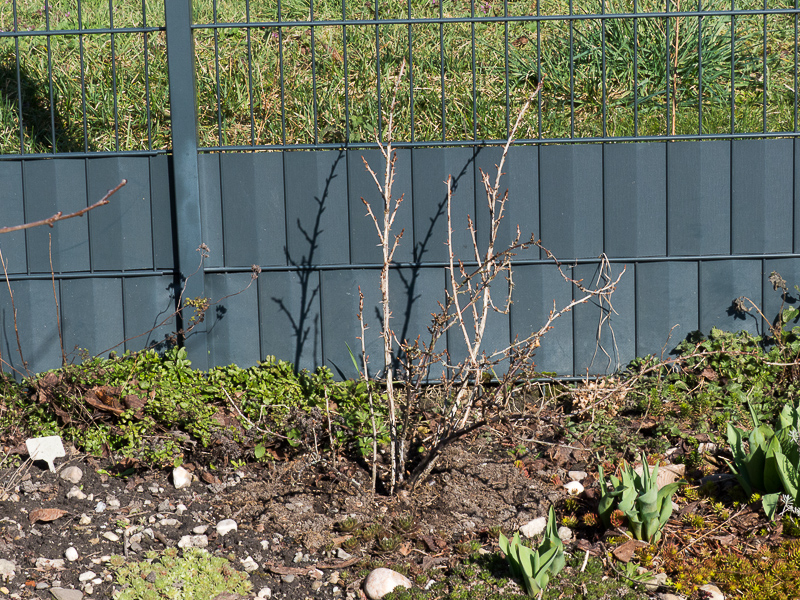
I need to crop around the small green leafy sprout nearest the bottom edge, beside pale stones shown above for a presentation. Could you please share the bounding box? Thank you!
[500,506,566,596]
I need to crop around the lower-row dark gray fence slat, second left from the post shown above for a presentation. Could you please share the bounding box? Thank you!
[61,278,125,362]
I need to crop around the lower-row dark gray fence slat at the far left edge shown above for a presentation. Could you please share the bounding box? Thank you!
[0,280,61,377]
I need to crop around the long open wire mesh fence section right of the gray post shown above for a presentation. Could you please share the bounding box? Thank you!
[193,0,800,151]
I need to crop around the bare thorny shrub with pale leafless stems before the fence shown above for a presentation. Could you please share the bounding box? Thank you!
[359,63,624,493]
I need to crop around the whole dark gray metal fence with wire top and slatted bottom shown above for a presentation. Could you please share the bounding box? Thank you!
[0,0,800,375]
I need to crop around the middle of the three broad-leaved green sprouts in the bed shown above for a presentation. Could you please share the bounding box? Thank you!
[598,453,680,543]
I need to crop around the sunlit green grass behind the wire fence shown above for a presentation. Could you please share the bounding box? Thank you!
[0,0,795,153]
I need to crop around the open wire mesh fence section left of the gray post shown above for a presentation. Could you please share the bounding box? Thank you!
[0,0,166,159]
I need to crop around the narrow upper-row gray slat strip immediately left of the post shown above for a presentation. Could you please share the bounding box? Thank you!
[150,156,177,269]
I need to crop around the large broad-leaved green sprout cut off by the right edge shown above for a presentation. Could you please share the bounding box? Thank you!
[728,403,800,519]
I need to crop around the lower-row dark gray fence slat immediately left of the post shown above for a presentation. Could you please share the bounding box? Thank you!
[122,275,177,351]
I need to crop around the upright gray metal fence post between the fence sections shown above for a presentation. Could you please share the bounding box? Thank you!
[164,0,208,370]
